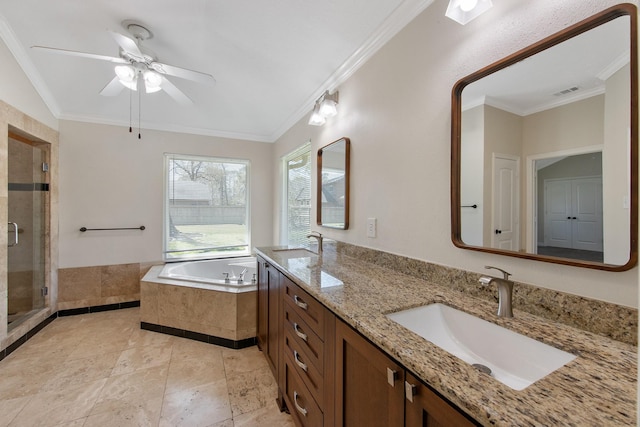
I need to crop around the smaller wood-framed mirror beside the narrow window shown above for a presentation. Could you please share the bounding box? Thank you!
[316,138,351,230]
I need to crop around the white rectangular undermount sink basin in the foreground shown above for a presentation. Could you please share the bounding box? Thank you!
[387,304,576,390]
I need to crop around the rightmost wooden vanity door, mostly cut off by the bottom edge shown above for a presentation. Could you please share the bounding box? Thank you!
[405,372,476,427]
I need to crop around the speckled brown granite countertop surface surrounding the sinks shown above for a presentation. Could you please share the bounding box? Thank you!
[257,247,637,426]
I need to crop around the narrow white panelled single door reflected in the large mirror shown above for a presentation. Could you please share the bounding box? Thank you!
[491,154,520,251]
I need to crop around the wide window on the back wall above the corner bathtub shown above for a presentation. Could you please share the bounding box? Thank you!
[164,154,250,261]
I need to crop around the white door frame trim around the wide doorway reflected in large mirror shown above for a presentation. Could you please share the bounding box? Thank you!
[524,144,604,254]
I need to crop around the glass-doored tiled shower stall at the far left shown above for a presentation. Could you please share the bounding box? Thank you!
[7,132,50,331]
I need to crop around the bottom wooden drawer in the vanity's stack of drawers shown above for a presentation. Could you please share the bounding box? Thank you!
[283,357,324,427]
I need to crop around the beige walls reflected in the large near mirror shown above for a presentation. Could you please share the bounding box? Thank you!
[461,65,630,264]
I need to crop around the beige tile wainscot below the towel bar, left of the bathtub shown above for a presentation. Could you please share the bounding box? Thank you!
[58,263,150,310]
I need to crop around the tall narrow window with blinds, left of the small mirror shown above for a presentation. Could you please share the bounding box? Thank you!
[282,143,311,246]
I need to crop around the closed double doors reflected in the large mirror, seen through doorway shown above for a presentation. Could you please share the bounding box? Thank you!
[544,177,602,252]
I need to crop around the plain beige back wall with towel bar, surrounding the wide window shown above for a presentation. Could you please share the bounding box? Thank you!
[60,121,274,268]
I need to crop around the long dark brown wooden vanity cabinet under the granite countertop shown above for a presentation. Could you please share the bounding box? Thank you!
[257,257,477,427]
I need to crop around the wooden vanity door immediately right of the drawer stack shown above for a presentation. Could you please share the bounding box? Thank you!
[335,321,404,427]
